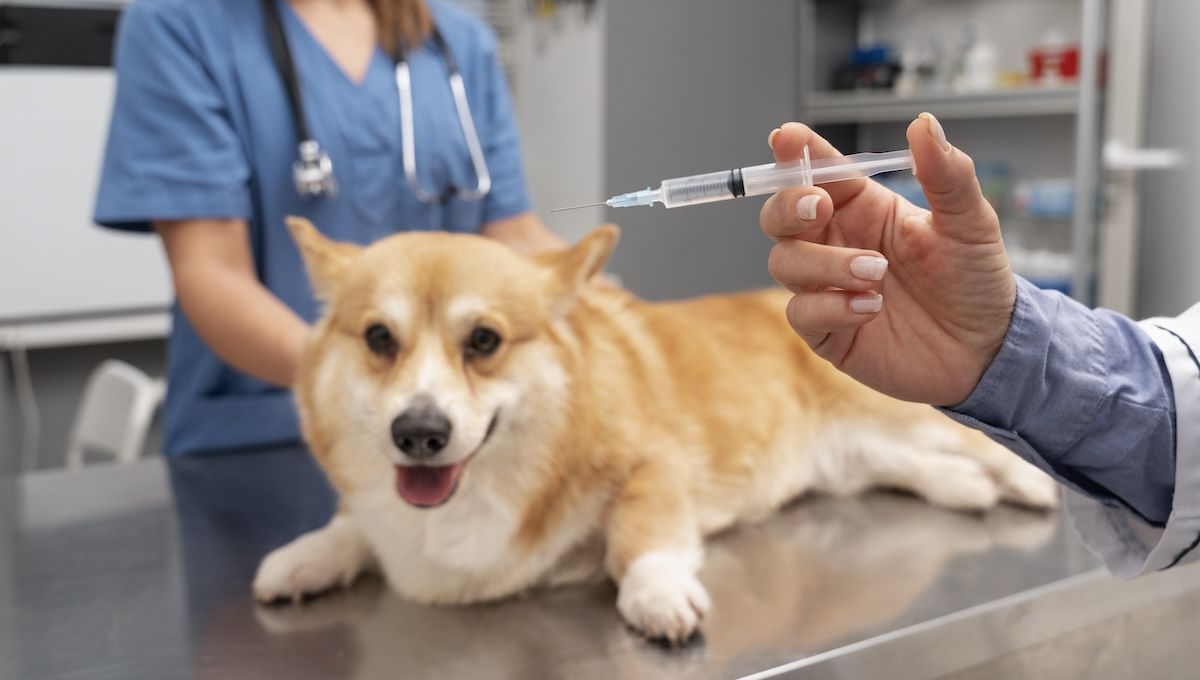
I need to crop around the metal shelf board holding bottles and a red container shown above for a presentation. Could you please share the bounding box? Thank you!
[805,86,1079,124]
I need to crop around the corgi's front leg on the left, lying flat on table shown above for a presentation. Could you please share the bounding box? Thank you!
[254,512,374,603]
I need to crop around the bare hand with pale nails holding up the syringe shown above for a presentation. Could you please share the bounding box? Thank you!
[760,114,1016,405]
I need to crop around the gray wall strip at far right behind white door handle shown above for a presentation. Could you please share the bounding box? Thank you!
[1136,0,1200,317]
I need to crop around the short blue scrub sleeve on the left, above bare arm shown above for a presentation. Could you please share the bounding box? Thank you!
[95,0,251,230]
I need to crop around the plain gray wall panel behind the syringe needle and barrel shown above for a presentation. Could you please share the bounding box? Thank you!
[605,0,797,299]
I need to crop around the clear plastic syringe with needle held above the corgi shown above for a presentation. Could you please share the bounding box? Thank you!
[551,146,912,212]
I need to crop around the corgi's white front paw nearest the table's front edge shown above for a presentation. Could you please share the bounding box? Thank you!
[617,552,712,644]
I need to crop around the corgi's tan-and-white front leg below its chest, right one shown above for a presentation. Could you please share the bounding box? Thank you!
[605,462,709,643]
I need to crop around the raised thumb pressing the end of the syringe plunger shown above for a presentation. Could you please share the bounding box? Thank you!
[907,113,996,236]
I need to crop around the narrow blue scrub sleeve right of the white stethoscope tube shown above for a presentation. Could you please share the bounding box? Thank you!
[470,29,530,224]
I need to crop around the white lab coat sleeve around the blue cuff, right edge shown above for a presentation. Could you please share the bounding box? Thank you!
[1066,305,1200,578]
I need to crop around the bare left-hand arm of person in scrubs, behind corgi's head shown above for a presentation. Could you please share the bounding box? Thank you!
[154,219,308,387]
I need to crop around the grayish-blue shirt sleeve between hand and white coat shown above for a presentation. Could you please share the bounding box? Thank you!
[943,278,1176,526]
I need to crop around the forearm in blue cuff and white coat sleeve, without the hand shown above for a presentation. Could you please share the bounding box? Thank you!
[947,289,1200,577]
